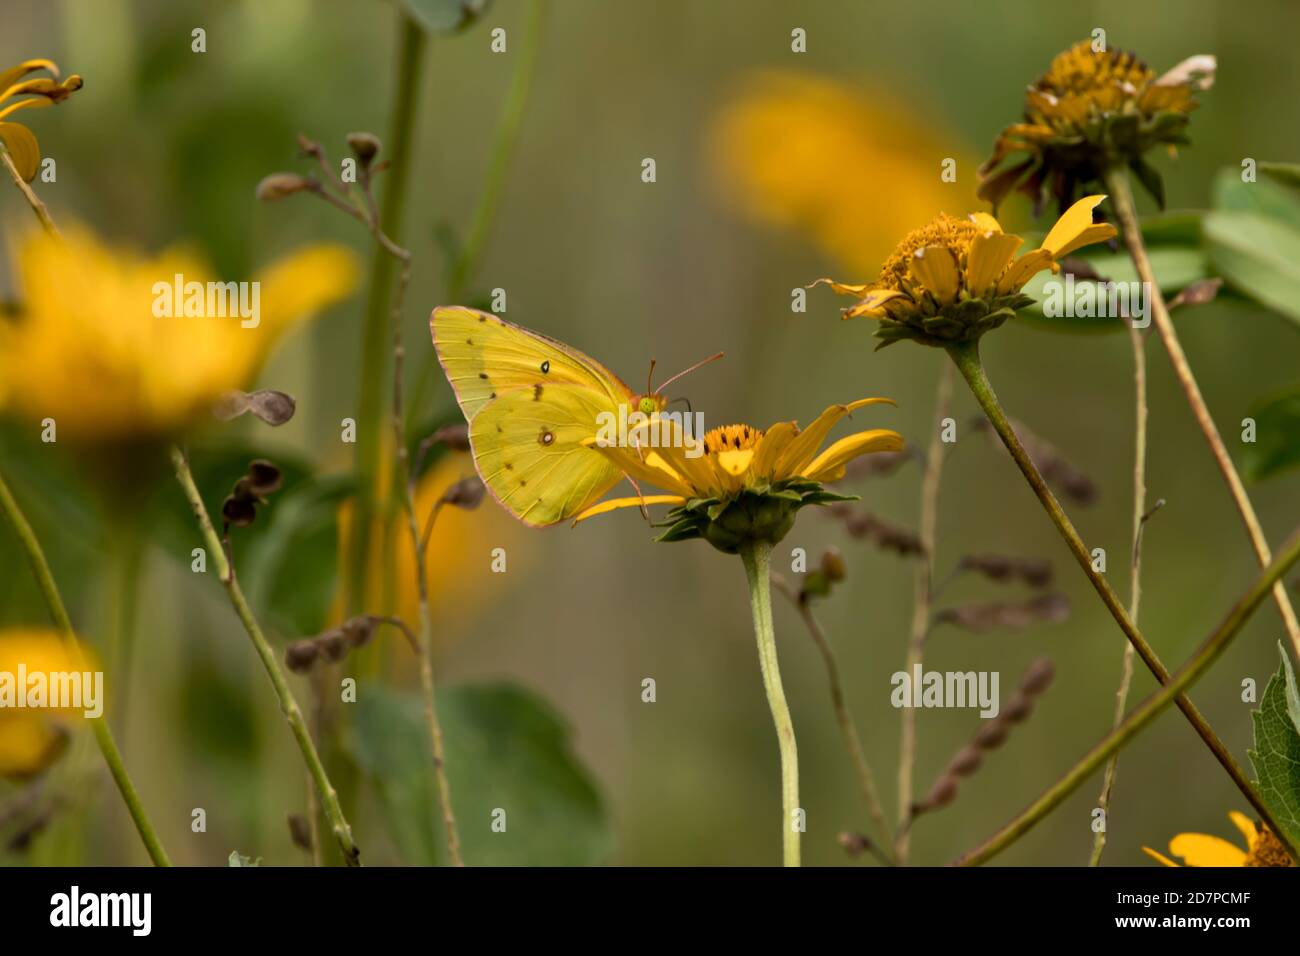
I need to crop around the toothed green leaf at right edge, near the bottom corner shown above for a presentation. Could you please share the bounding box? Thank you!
[1249,645,1300,845]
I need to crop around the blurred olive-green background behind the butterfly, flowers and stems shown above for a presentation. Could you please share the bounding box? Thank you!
[0,0,1300,865]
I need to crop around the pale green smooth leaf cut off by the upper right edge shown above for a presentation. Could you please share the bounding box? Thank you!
[1205,208,1300,324]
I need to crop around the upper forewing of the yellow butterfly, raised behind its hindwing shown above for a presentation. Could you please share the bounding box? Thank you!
[429,306,632,421]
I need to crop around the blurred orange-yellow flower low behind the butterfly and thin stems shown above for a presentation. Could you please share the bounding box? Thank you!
[340,454,529,646]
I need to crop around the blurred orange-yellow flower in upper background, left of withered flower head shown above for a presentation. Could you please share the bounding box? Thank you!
[712,72,975,272]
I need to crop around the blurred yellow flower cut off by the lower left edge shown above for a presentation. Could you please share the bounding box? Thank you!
[0,628,95,779]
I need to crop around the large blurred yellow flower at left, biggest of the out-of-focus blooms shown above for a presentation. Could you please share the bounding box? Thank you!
[0,224,358,444]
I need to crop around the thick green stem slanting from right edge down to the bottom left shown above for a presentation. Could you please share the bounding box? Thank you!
[953,522,1300,866]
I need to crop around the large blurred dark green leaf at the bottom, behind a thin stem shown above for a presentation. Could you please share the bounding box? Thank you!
[351,684,614,866]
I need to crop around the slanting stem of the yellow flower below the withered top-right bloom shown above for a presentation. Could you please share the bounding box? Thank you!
[948,342,1271,826]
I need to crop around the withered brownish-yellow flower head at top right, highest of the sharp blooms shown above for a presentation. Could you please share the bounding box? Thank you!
[979,40,1216,215]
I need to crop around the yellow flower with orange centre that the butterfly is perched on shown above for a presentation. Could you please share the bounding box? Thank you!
[573,398,904,554]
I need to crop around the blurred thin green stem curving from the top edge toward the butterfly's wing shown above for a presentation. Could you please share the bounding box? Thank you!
[411,0,546,429]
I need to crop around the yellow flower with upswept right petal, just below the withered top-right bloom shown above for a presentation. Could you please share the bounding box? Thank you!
[814,196,1115,349]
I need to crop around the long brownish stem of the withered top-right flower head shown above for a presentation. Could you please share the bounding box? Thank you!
[1104,166,1300,659]
